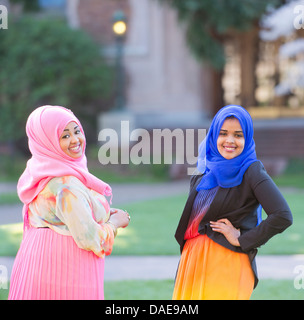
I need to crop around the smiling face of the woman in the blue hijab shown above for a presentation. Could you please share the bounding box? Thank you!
[217,118,245,160]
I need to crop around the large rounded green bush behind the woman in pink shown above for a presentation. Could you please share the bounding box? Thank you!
[0,17,113,141]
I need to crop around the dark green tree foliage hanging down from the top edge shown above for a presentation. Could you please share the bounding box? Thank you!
[162,0,280,70]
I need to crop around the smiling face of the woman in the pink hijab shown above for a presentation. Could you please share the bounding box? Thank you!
[59,122,85,159]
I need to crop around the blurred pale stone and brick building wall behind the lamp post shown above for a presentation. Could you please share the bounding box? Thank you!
[67,0,210,126]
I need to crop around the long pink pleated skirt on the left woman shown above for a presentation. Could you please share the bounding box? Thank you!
[8,228,104,300]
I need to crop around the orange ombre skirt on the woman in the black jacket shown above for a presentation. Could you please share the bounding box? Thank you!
[173,235,254,300]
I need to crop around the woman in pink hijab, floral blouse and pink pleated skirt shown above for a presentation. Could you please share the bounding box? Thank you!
[9,106,130,300]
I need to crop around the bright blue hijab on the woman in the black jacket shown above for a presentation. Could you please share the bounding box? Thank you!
[197,105,261,221]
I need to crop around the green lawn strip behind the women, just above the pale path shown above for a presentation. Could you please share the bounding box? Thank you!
[0,193,304,256]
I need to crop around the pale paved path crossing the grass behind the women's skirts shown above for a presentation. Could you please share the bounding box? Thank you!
[0,255,304,281]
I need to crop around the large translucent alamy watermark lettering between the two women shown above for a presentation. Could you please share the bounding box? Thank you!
[98,121,206,175]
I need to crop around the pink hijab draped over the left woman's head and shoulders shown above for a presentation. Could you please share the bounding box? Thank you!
[17,106,112,229]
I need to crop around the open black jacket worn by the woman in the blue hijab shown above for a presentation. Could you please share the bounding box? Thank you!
[175,161,292,287]
